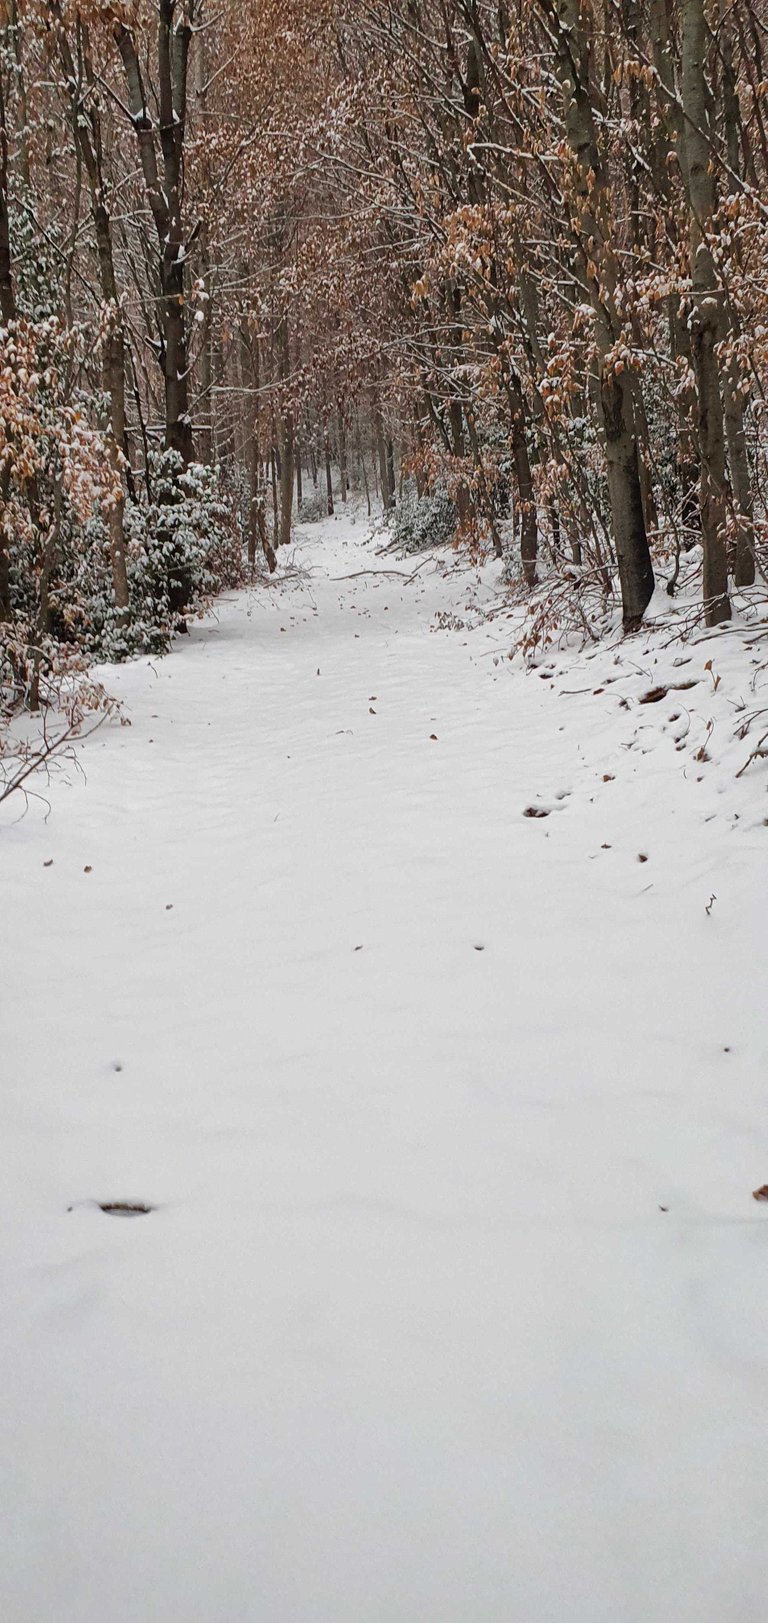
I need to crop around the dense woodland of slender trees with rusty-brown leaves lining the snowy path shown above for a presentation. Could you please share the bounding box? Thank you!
[0,0,768,710]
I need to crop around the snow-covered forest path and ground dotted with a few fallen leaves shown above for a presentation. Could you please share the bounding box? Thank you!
[0,519,768,1623]
